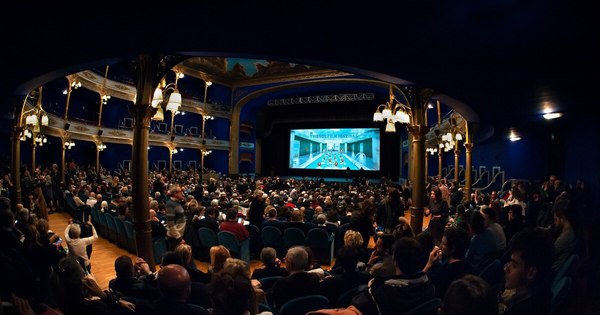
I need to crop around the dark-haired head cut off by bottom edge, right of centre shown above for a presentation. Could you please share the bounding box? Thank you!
[442,275,498,315]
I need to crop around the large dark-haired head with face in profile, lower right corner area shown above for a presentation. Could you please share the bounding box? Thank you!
[504,229,554,290]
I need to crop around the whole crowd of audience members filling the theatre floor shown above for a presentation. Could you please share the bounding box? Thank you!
[0,160,589,314]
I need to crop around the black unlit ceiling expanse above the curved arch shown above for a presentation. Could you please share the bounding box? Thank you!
[0,0,600,141]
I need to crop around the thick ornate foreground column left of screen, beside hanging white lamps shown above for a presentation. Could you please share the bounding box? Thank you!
[131,55,159,271]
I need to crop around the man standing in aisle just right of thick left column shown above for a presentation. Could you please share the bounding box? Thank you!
[165,185,185,250]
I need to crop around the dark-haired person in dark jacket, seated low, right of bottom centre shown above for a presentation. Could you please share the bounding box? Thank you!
[352,237,435,315]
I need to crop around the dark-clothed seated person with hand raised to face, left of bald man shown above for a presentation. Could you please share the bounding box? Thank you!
[108,255,160,301]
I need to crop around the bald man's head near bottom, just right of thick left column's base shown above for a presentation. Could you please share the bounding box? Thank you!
[158,264,192,302]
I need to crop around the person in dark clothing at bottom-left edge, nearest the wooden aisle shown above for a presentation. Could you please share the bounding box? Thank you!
[52,256,136,315]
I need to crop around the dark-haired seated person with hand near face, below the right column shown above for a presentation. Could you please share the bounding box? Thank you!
[423,228,477,298]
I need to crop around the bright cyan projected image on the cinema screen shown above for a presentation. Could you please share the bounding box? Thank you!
[289,128,380,171]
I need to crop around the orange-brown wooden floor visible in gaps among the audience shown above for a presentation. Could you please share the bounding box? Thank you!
[49,212,429,289]
